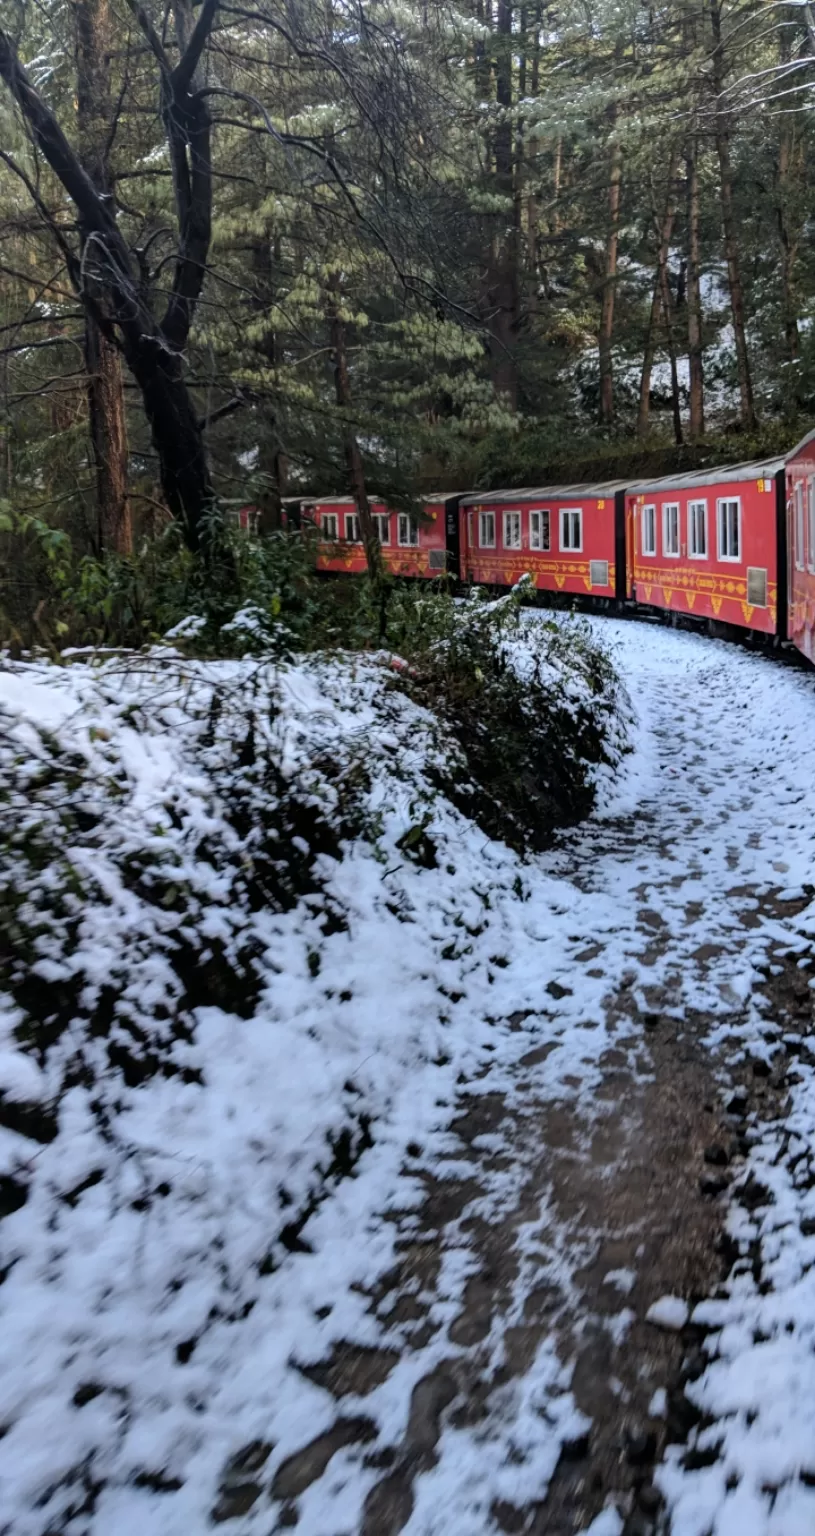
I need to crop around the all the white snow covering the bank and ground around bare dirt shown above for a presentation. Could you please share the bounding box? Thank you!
[0,617,815,1536]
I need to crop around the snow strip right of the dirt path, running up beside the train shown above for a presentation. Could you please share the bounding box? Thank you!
[555,625,815,1536]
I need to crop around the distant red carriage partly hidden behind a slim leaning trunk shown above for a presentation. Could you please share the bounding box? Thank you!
[299,493,459,579]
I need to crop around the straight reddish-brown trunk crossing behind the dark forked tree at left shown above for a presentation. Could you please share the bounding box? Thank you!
[75,0,134,554]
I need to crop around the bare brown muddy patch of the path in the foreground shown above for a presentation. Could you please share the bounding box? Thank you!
[259,828,734,1536]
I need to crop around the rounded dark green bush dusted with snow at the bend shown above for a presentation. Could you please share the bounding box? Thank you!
[388,578,628,848]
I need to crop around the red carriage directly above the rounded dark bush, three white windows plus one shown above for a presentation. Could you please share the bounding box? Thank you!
[459,481,626,598]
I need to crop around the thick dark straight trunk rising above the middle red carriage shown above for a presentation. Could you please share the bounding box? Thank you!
[488,0,520,410]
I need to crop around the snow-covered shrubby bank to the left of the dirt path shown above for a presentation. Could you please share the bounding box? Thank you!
[0,626,632,1536]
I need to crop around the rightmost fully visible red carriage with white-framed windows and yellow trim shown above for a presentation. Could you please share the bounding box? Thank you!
[626,459,786,634]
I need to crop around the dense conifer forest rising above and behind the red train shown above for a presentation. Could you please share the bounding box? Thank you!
[0,0,815,595]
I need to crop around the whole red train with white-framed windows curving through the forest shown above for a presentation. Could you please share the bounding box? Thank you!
[292,432,815,662]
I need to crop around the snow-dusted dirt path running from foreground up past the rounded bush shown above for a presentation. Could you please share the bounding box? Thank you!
[215,626,815,1536]
